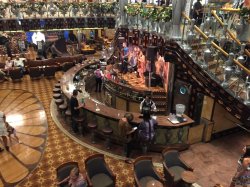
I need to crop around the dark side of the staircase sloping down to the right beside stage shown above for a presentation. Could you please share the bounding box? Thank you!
[166,41,250,126]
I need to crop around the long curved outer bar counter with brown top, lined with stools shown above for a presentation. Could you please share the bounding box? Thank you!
[61,62,194,146]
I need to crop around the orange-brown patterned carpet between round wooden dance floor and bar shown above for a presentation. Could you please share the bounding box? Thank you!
[0,72,150,187]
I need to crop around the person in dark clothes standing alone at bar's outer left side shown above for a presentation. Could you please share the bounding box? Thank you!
[70,90,84,133]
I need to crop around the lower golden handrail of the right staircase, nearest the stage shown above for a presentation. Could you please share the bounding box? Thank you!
[182,12,250,75]
